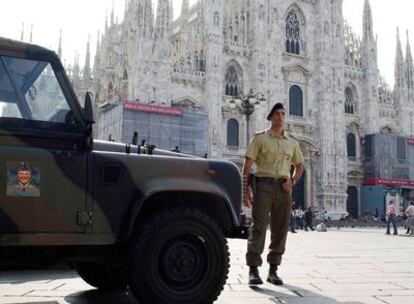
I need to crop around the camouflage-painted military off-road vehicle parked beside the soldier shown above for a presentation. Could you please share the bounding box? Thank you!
[0,38,243,304]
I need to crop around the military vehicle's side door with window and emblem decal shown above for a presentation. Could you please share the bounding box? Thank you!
[0,53,88,237]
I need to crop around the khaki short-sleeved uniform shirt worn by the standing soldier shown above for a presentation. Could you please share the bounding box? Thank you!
[245,129,303,178]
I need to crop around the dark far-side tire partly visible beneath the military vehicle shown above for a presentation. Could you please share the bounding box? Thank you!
[76,262,128,290]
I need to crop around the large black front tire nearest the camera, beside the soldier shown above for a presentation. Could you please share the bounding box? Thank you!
[128,208,229,304]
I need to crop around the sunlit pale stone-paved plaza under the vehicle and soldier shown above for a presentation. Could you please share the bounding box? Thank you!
[0,229,414,304]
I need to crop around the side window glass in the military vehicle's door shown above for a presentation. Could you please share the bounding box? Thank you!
[0,56,74,124]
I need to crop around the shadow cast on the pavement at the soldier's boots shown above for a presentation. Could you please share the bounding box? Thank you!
[250,284,364,304]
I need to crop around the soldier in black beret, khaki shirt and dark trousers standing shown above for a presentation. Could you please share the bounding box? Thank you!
[243,103,303,285]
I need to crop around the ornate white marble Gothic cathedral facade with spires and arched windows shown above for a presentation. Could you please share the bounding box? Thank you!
[83,0,414,218]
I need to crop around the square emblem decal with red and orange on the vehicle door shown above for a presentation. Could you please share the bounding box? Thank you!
[7,161,40,197]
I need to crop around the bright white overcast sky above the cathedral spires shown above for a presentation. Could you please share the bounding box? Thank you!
[0,0,414,85]
